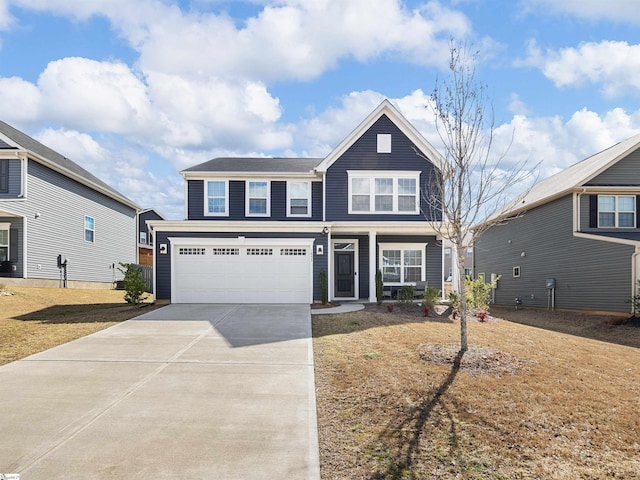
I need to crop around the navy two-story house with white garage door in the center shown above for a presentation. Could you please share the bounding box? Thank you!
[148,100,443,303]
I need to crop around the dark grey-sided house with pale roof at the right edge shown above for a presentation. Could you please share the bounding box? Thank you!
[474,131,640,312]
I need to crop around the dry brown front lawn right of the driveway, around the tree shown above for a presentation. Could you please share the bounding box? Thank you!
[313,306,640,479]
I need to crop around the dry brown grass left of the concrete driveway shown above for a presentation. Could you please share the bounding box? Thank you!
[0,286,164,365]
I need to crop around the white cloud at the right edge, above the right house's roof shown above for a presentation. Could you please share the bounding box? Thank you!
[519,41,640,97]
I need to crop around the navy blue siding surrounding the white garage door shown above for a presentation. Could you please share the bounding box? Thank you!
[154,231,329,300]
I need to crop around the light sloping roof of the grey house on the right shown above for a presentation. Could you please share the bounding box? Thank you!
[482,134,640,223]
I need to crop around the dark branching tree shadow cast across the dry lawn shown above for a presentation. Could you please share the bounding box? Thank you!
[369,353,462,480]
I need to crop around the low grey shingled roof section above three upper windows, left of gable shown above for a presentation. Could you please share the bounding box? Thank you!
[180,157,322,177]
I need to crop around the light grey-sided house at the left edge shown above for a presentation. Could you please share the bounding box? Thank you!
[0,121,138,286]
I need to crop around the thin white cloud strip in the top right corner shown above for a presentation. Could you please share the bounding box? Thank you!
[522,0,640,23]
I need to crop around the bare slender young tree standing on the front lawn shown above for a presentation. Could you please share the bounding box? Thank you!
[424,40,532,355]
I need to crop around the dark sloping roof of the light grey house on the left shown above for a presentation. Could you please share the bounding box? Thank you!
[0,120,139,210]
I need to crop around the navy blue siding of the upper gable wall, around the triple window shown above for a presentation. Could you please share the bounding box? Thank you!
[326,115,441,222]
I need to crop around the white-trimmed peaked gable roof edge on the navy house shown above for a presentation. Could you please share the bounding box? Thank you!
[317,98,445,172]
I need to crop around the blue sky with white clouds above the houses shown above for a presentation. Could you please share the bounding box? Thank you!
[0,0,640,219]
